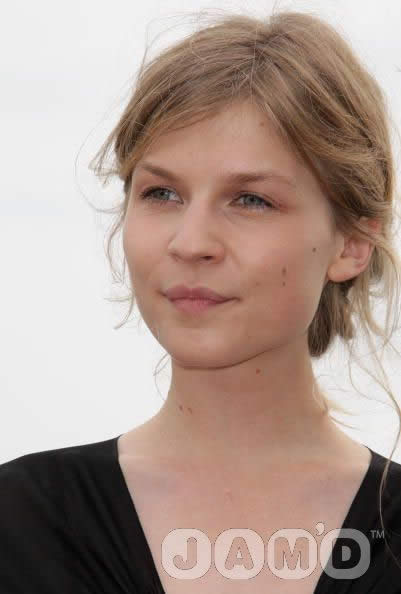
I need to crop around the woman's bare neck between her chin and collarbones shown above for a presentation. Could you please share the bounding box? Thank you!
[134,344,350,471]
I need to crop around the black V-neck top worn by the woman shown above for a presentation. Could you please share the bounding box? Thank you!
[0,436,401,594]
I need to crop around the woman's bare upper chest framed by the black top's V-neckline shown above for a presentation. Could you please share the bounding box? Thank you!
[120,457,363,594]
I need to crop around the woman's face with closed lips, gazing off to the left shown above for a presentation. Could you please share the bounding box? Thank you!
[123,103,336,368]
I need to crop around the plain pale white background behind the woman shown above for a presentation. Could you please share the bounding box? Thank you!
[0,0,401,462]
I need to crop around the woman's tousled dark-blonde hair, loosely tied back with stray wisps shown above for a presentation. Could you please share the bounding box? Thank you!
[90,11,401,559]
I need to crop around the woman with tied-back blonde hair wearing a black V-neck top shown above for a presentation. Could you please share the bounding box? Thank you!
[0,6,401,594]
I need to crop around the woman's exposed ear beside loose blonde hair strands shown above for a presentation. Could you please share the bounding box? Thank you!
[327,217,381,282]
